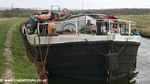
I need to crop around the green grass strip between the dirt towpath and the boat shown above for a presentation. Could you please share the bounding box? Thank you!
[12,18,39,84]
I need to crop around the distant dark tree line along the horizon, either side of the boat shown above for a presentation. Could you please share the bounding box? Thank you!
[0,8,150,17]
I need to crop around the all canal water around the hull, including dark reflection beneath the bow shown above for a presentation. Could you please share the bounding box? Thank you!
[49,38,150,84]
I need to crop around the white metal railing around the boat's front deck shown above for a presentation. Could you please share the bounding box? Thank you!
[37,18,135,36]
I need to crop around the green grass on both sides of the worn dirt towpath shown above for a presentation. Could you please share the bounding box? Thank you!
[0,18,39,84]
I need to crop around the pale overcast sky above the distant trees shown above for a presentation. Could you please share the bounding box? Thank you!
[0,0,150,9]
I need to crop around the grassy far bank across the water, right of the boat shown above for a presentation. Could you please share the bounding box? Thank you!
[118,14,150,38]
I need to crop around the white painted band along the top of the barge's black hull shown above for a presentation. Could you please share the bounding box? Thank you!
[27,34,140,45]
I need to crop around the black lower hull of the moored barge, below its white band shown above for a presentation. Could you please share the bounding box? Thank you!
[35,41,140,80]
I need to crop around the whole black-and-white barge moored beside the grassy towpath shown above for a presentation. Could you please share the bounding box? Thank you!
[22,9,140,80]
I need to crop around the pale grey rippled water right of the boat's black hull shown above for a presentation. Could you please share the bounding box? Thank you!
[131,38,150,84]
